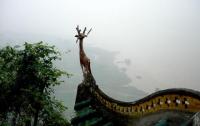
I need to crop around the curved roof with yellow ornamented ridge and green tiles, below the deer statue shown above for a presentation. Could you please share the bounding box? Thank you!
[71,75,200,126]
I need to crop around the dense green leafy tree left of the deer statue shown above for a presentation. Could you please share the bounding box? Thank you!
[0,42,70,126]
